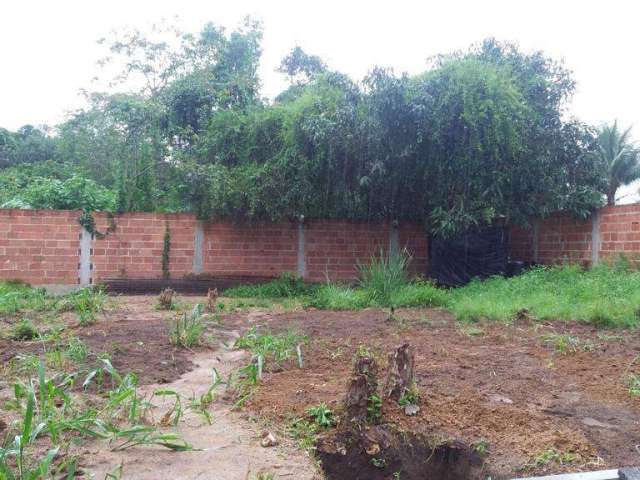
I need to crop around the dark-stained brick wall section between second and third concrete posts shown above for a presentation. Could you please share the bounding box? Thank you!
[203,222,298,277]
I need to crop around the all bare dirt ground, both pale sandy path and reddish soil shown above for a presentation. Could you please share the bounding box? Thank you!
[0,296,640,480]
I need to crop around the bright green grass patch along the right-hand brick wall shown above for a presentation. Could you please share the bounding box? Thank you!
[448,262,640,327]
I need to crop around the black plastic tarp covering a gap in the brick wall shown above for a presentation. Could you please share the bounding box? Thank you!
[429,226,509,287]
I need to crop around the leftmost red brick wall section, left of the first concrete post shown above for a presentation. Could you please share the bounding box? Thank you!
[0,209,81,285]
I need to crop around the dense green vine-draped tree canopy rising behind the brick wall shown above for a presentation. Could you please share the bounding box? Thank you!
[0,20,607,235]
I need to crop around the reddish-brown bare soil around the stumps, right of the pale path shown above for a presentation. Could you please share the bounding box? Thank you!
[239,310,640,478]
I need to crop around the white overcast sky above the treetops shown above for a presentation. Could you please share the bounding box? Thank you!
[0,0,640,197]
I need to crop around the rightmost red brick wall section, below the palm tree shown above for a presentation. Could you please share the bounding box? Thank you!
[600,203,640,261]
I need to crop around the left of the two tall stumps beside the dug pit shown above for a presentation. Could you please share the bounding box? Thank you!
[344,357,378,425]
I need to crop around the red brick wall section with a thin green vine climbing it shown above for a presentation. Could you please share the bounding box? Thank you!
[91,212,196,282]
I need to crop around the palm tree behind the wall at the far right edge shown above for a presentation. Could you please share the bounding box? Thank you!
[595,121,640,205]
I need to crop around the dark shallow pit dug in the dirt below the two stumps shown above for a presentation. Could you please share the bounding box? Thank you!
[318,425,488,480]
